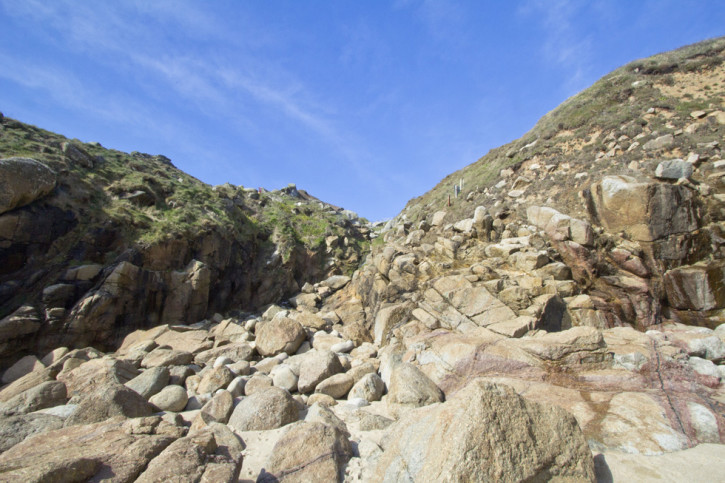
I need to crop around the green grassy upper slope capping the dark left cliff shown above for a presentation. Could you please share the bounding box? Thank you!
[0,118,364,263]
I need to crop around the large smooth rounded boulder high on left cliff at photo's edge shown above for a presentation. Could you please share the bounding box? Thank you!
[0,158,56,214]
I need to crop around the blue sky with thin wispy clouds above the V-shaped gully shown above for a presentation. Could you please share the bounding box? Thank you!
[0,0,725,220]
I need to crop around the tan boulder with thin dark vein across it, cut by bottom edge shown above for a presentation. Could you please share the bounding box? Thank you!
[257,421,352,482]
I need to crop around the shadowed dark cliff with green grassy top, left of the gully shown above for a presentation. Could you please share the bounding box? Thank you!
[0,118,370,363]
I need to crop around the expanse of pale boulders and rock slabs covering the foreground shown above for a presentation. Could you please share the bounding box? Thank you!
[0,250,725,481]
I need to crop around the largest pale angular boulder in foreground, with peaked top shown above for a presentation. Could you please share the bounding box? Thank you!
[373,380,594,481]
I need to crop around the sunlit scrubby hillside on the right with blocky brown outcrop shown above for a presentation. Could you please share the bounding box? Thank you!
[389,38,725,328]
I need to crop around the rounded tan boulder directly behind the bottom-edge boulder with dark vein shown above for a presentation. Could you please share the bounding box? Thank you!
[228,387,299,431]
